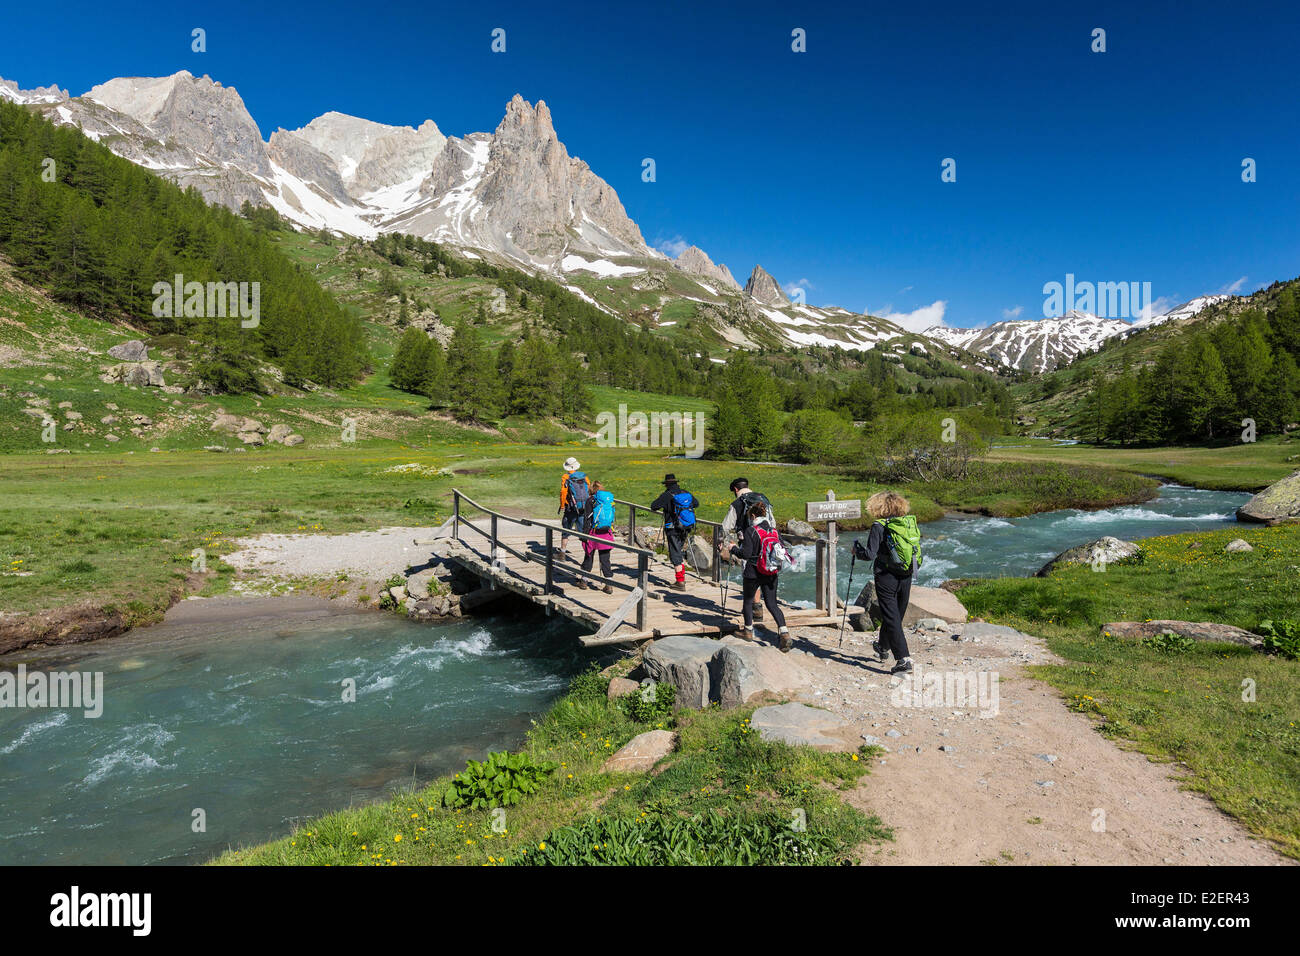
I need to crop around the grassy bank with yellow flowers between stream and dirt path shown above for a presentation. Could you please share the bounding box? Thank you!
[217,674,889,866]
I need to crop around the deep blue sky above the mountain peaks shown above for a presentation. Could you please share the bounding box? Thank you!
[0,0,1300,326]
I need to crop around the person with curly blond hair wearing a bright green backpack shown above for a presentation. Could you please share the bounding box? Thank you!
[853,492,920,674]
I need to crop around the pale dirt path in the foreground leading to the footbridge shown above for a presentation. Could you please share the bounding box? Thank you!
[769,626,1294,865]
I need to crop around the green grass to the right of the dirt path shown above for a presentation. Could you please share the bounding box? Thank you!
[961,525,1300,857]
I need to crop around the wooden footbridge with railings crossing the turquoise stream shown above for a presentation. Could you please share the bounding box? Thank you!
[432,489,857,646]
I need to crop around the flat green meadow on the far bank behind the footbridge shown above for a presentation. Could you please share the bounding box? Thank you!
[0,442,1154,650]
